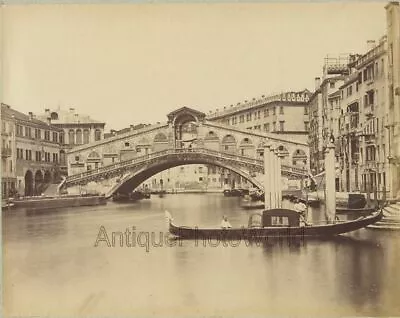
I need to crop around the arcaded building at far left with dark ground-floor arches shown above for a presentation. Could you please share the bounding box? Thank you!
[1,104,62,197]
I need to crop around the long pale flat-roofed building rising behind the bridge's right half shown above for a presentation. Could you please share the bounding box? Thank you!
[203,90,311,188]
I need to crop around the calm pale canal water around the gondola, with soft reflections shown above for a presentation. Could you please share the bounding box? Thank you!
[3,194,400,317]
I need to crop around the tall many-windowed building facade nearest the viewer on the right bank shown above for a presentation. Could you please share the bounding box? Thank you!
[338,37,391,195]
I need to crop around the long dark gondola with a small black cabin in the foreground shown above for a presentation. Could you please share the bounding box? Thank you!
[165,209,383,240]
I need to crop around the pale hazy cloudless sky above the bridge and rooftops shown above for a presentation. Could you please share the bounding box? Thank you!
[2,2,386,129]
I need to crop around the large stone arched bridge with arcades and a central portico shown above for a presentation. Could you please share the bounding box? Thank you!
[60,107,309,196]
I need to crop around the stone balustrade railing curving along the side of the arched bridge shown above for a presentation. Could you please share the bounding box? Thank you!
[65,148,307,183]
